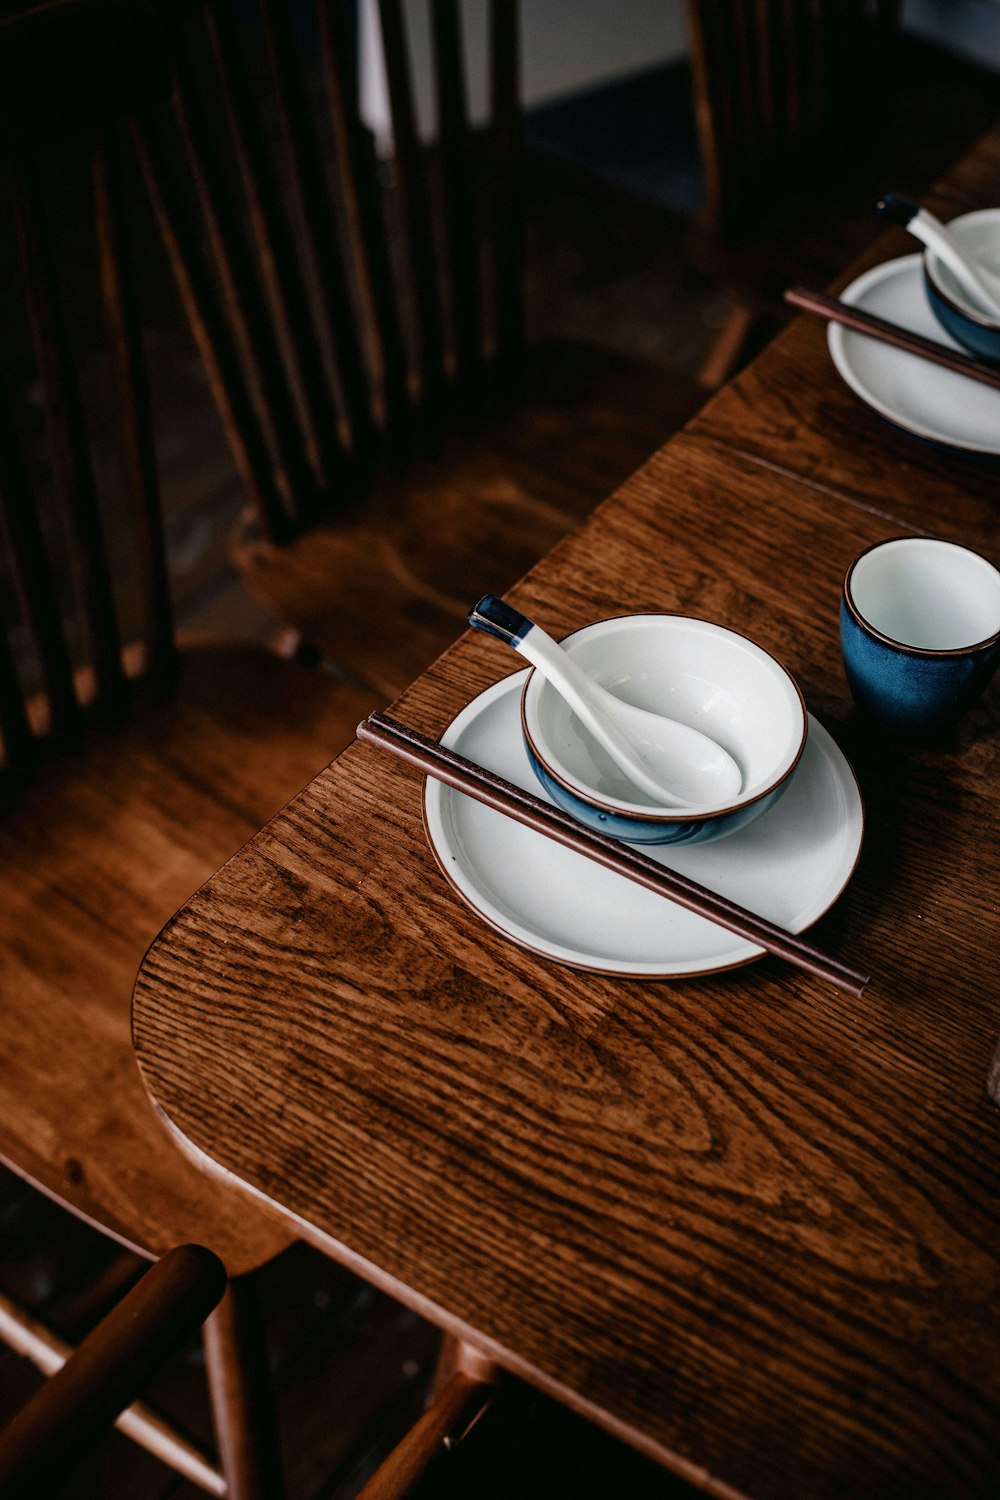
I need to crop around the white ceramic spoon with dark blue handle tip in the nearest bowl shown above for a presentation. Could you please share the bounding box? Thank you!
[469,594,744,809]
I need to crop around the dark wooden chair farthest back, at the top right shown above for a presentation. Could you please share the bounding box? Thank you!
[687,0,1000,389]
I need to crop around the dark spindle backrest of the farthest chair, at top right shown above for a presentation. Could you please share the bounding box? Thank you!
[688,0,900,239]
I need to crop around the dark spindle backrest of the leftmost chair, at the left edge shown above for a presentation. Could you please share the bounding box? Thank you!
[0,0,174,767]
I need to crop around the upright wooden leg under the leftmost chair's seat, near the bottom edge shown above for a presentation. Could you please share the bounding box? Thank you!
[202,1277,283,1500]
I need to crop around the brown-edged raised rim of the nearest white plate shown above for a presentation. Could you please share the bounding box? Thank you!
[421,668,865,980]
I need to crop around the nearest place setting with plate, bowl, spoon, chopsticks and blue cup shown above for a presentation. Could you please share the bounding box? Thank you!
[358,519,1000,995]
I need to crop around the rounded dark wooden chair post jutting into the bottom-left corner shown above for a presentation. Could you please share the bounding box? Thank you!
[0,1245,226,1500]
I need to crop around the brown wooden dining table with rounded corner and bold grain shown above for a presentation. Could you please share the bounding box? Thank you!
[135,138,1000,1500]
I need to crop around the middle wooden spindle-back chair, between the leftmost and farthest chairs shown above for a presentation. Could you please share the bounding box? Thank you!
[135,0,700,693]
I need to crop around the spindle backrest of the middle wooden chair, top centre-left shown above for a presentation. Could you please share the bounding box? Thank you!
[133,0,520,552]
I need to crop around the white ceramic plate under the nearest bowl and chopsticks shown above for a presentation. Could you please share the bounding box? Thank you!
[424,672,864,978]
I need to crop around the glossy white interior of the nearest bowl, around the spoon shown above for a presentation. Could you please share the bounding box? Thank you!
[523,615,807,818]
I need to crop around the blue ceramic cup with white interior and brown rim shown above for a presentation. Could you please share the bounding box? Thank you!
[840,537,1000,740]
